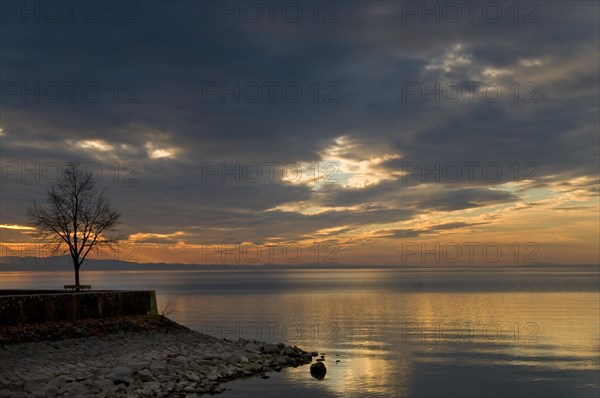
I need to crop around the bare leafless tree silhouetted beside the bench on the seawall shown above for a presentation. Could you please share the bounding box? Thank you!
[27,163,121,290]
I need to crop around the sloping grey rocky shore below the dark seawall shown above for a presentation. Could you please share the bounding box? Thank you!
[0,316,316,398]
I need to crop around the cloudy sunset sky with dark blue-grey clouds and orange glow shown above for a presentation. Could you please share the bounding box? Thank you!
[0,0,600,266]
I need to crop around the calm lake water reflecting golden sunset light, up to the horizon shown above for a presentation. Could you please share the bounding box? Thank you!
[0,267,600,398]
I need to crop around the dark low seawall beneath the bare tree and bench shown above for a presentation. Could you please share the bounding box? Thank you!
[0,290,157,325]
